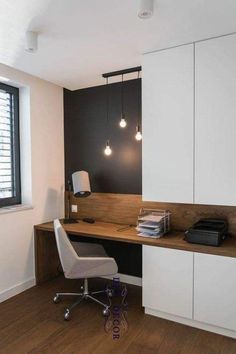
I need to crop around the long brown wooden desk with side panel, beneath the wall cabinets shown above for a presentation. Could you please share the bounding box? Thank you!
[35,221,236,284]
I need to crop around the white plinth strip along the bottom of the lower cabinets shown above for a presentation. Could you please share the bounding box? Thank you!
[145,307,236,338]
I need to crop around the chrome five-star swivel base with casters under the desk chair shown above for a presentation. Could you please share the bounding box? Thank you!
[53,279,112,321]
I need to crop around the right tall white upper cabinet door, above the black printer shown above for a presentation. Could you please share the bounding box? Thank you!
[195,35,236,205]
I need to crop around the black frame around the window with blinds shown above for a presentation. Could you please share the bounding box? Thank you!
[0,82,21,208]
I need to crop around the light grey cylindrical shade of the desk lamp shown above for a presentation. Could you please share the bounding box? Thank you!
[72,171,91,198]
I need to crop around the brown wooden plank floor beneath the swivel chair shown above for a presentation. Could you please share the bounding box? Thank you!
[0,277,236,354]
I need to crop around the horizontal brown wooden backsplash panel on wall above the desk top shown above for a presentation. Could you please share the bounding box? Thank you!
[65,193,236,236]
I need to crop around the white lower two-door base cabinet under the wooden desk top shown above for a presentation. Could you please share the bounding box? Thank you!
[143,246,236,338]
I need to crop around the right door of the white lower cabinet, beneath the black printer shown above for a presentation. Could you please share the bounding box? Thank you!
[194,253,236,331]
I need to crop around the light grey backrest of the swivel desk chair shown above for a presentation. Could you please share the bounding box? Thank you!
[54,219,79,276]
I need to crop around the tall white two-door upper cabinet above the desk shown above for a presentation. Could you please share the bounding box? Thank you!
[142,34,236,205]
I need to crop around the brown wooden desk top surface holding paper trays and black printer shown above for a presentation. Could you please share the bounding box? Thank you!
[35,221,236,257]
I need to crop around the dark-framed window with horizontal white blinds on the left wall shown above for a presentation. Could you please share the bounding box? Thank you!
[0,83,21,207]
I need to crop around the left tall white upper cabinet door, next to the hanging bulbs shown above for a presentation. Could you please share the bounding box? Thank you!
[142,44,194,203]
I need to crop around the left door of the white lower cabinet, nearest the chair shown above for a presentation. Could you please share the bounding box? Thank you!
[143,246,193,318]
